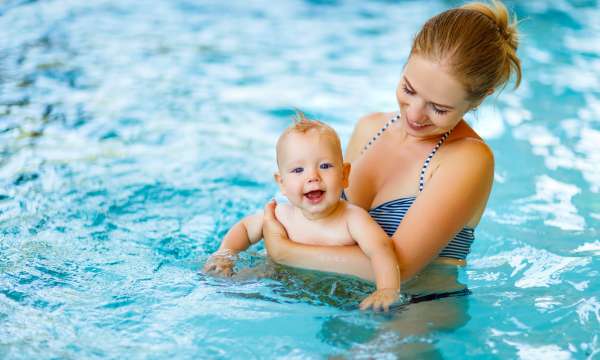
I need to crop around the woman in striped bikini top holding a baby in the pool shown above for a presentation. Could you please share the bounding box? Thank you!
[263,1,521,292]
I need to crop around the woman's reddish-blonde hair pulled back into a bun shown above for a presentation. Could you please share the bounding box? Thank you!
[410,0,521,102]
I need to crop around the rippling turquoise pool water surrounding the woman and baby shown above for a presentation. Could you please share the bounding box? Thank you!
[0,0,600,359]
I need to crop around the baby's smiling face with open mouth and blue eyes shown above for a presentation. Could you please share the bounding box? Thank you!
[275,130,350,219]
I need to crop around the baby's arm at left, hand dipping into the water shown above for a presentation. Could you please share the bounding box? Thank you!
[203,212,263,276]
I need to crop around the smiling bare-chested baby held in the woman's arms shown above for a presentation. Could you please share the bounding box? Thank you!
[204,114,400,311]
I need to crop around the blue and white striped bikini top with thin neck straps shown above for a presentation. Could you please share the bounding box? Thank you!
[342,114,475,260]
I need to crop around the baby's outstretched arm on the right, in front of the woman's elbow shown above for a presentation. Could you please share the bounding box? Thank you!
[348,207,400,311]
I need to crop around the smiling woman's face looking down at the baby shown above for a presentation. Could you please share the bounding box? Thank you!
[396,54,472,138]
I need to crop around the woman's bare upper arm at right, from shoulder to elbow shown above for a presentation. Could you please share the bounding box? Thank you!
[392,139,494,278]
